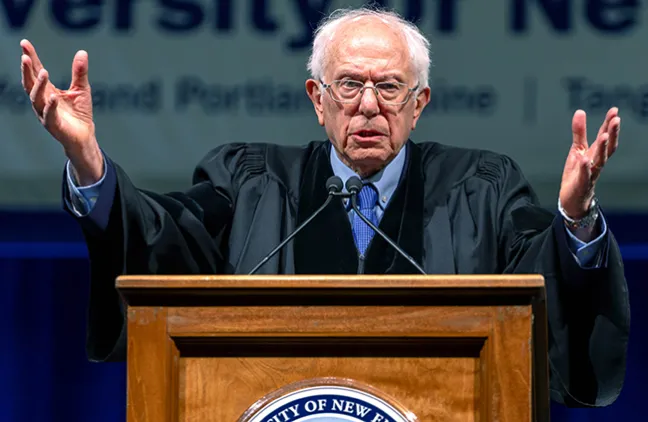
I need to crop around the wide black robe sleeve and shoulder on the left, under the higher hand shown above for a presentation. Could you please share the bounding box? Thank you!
[63,144,294,361]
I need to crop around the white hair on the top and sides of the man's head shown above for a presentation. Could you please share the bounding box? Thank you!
[307,7,430,89]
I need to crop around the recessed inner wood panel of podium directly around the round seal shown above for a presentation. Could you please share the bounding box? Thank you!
[179,357,479,422]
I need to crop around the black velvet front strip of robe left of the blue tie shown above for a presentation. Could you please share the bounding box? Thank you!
[293,142,358,274]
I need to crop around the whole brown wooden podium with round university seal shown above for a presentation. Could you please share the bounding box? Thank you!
[116,275,549,422]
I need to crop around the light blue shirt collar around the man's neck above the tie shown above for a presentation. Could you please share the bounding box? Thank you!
[330,144,407,209]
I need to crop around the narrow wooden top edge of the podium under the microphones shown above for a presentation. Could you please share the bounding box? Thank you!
[116,274,544,289]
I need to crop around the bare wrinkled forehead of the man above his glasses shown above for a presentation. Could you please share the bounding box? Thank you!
[325,17,415,81]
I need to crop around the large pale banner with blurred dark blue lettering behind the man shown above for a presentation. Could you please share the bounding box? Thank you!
[0,0,648,208]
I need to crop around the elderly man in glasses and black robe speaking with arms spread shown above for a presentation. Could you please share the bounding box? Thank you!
[21,5,629,406]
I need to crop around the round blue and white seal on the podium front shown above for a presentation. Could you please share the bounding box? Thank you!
[238,378,417,422]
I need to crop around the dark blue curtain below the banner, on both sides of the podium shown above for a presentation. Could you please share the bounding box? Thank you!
[0,211,648,422]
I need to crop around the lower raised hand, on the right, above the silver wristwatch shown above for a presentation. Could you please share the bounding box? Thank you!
[560,107,621,219]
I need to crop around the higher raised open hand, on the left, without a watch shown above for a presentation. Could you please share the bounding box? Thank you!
[20,40,103,185]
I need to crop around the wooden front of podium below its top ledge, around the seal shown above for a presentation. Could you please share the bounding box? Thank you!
[129,306,532,422]
